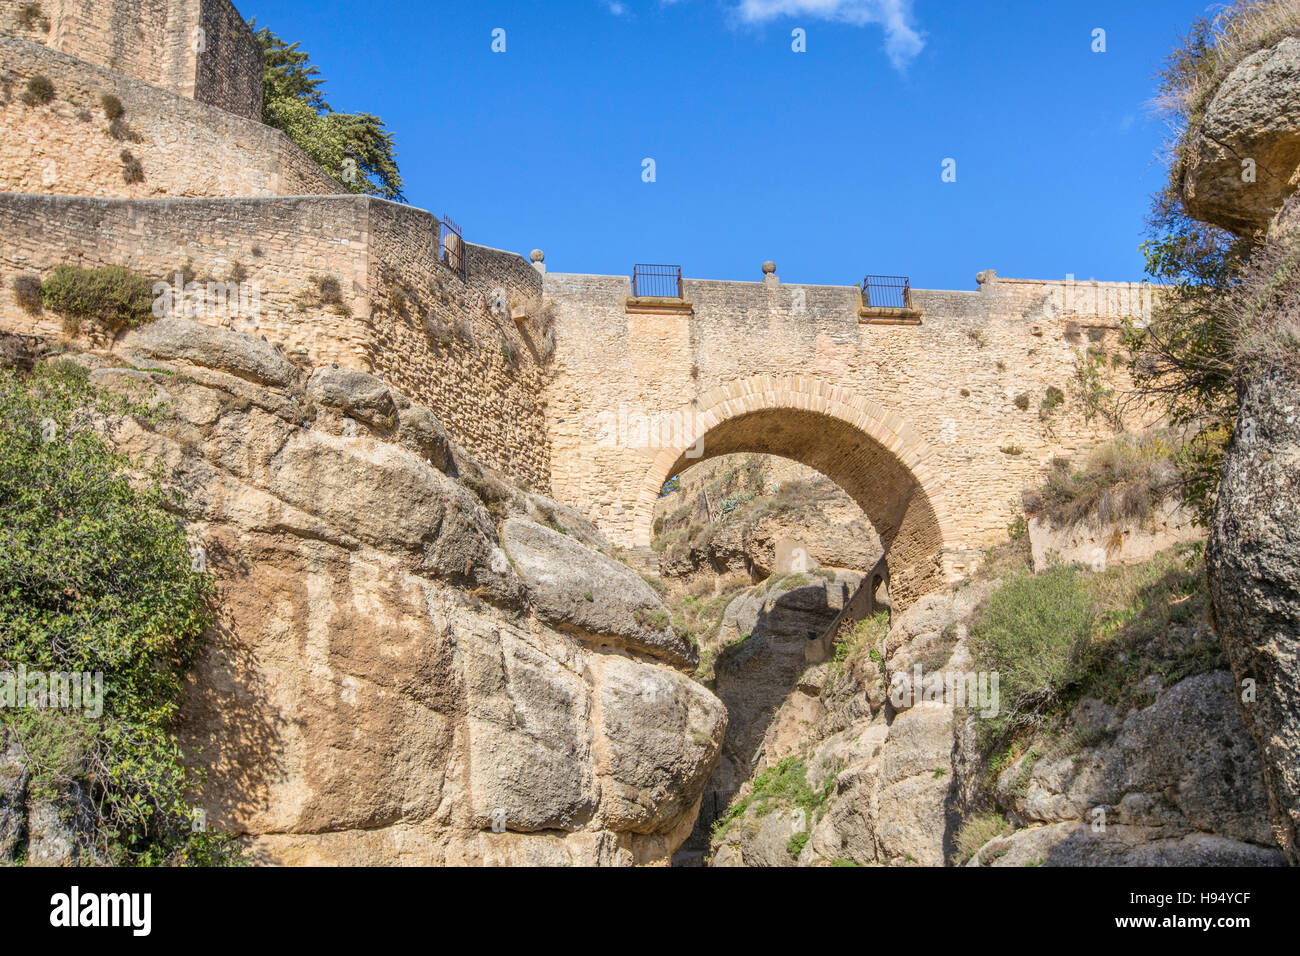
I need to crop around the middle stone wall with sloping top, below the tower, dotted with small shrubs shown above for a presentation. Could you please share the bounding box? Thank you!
[0,35,343,198]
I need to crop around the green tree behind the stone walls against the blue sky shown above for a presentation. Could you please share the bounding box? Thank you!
[252,21,406,202]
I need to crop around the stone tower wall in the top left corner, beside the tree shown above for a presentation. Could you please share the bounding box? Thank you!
[0,0,261,120]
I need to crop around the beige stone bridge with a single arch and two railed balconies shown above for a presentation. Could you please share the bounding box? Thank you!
[543,265,1151,604]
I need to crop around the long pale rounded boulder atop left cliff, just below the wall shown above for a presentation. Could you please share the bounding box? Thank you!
[122,317,298,388]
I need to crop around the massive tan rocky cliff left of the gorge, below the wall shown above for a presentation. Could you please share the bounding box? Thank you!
[20,320,727,865]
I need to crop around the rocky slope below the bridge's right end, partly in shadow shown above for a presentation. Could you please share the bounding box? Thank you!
[712,546,1284,866]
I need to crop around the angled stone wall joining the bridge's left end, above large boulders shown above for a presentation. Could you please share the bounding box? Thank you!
[0,194,550,489]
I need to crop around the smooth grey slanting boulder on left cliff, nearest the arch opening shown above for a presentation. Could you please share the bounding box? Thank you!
[502,518,696,667]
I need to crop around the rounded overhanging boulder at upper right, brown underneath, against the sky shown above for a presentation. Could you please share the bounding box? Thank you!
[1182,36,1300,234]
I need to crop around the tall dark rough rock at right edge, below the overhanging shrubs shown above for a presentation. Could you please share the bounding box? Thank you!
[1206,372,1300,865]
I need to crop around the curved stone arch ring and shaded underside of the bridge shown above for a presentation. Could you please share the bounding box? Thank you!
[633,376,954,607]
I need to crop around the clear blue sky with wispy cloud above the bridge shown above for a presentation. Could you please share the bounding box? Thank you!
[237,0,1206,289]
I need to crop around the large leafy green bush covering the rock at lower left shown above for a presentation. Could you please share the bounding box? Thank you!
[0,360,235,865]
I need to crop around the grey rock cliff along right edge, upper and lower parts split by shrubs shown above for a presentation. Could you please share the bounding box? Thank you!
[1180,31,1300,865]
